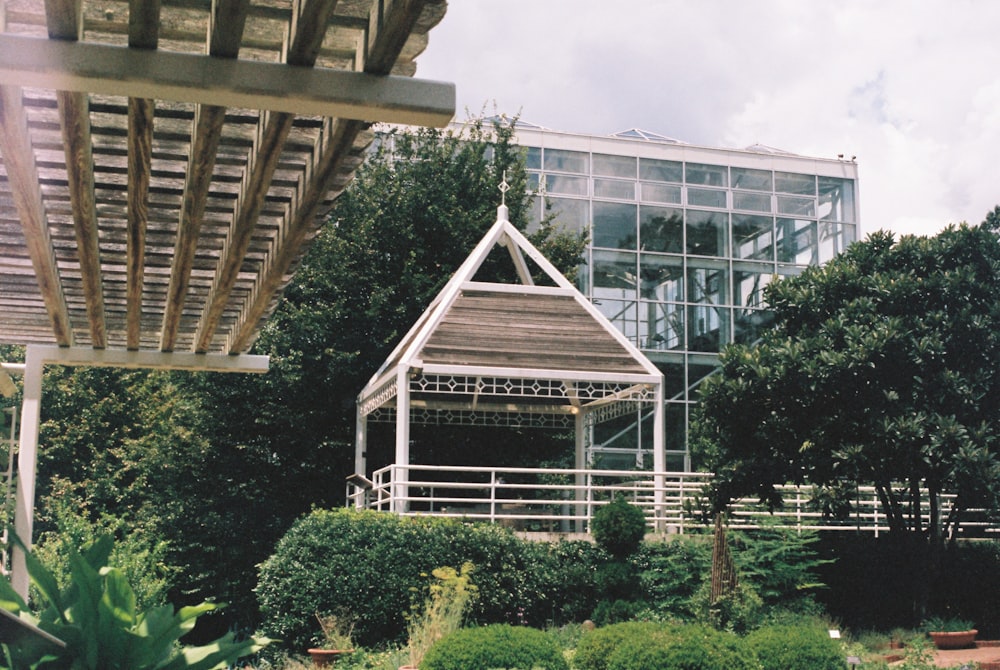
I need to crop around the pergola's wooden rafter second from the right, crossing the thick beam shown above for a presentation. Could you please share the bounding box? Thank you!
[195,0,337,353]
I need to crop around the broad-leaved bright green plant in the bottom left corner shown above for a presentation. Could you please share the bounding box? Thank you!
[0,536,268,670]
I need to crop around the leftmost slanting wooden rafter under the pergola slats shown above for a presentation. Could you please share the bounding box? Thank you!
[0,86,74,347]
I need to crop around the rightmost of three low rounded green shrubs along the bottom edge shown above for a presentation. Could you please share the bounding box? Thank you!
[747,625,844,670]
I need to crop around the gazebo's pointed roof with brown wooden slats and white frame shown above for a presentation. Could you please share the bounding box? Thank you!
[358,206,662,426]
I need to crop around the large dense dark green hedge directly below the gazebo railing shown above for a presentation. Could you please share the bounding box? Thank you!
[257,509,599,650]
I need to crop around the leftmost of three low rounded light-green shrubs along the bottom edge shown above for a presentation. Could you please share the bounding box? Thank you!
[420,624,569,670]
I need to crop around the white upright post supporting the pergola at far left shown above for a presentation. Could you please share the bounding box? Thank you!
[10,345,44,600]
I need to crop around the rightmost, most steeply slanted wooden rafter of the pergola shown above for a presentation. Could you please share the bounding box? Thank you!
[227,0,435,353]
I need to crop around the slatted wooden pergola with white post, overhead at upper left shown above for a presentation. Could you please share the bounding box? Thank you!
[0,0,455,590]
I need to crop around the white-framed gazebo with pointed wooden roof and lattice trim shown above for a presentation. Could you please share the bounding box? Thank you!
[349,197,666,528]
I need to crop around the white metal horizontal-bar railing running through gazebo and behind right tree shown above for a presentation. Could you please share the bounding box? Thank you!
[347,465,1000,536]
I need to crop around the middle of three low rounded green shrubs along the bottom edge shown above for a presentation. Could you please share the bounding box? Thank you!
[607,625,760,670]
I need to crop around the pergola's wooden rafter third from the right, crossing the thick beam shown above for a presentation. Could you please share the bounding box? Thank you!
[160,0,250,351]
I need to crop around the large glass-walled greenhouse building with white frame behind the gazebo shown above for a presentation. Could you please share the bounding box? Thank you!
[517,122,858,470]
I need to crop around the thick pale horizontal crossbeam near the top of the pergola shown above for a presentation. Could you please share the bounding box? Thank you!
[0,34,455,127]
